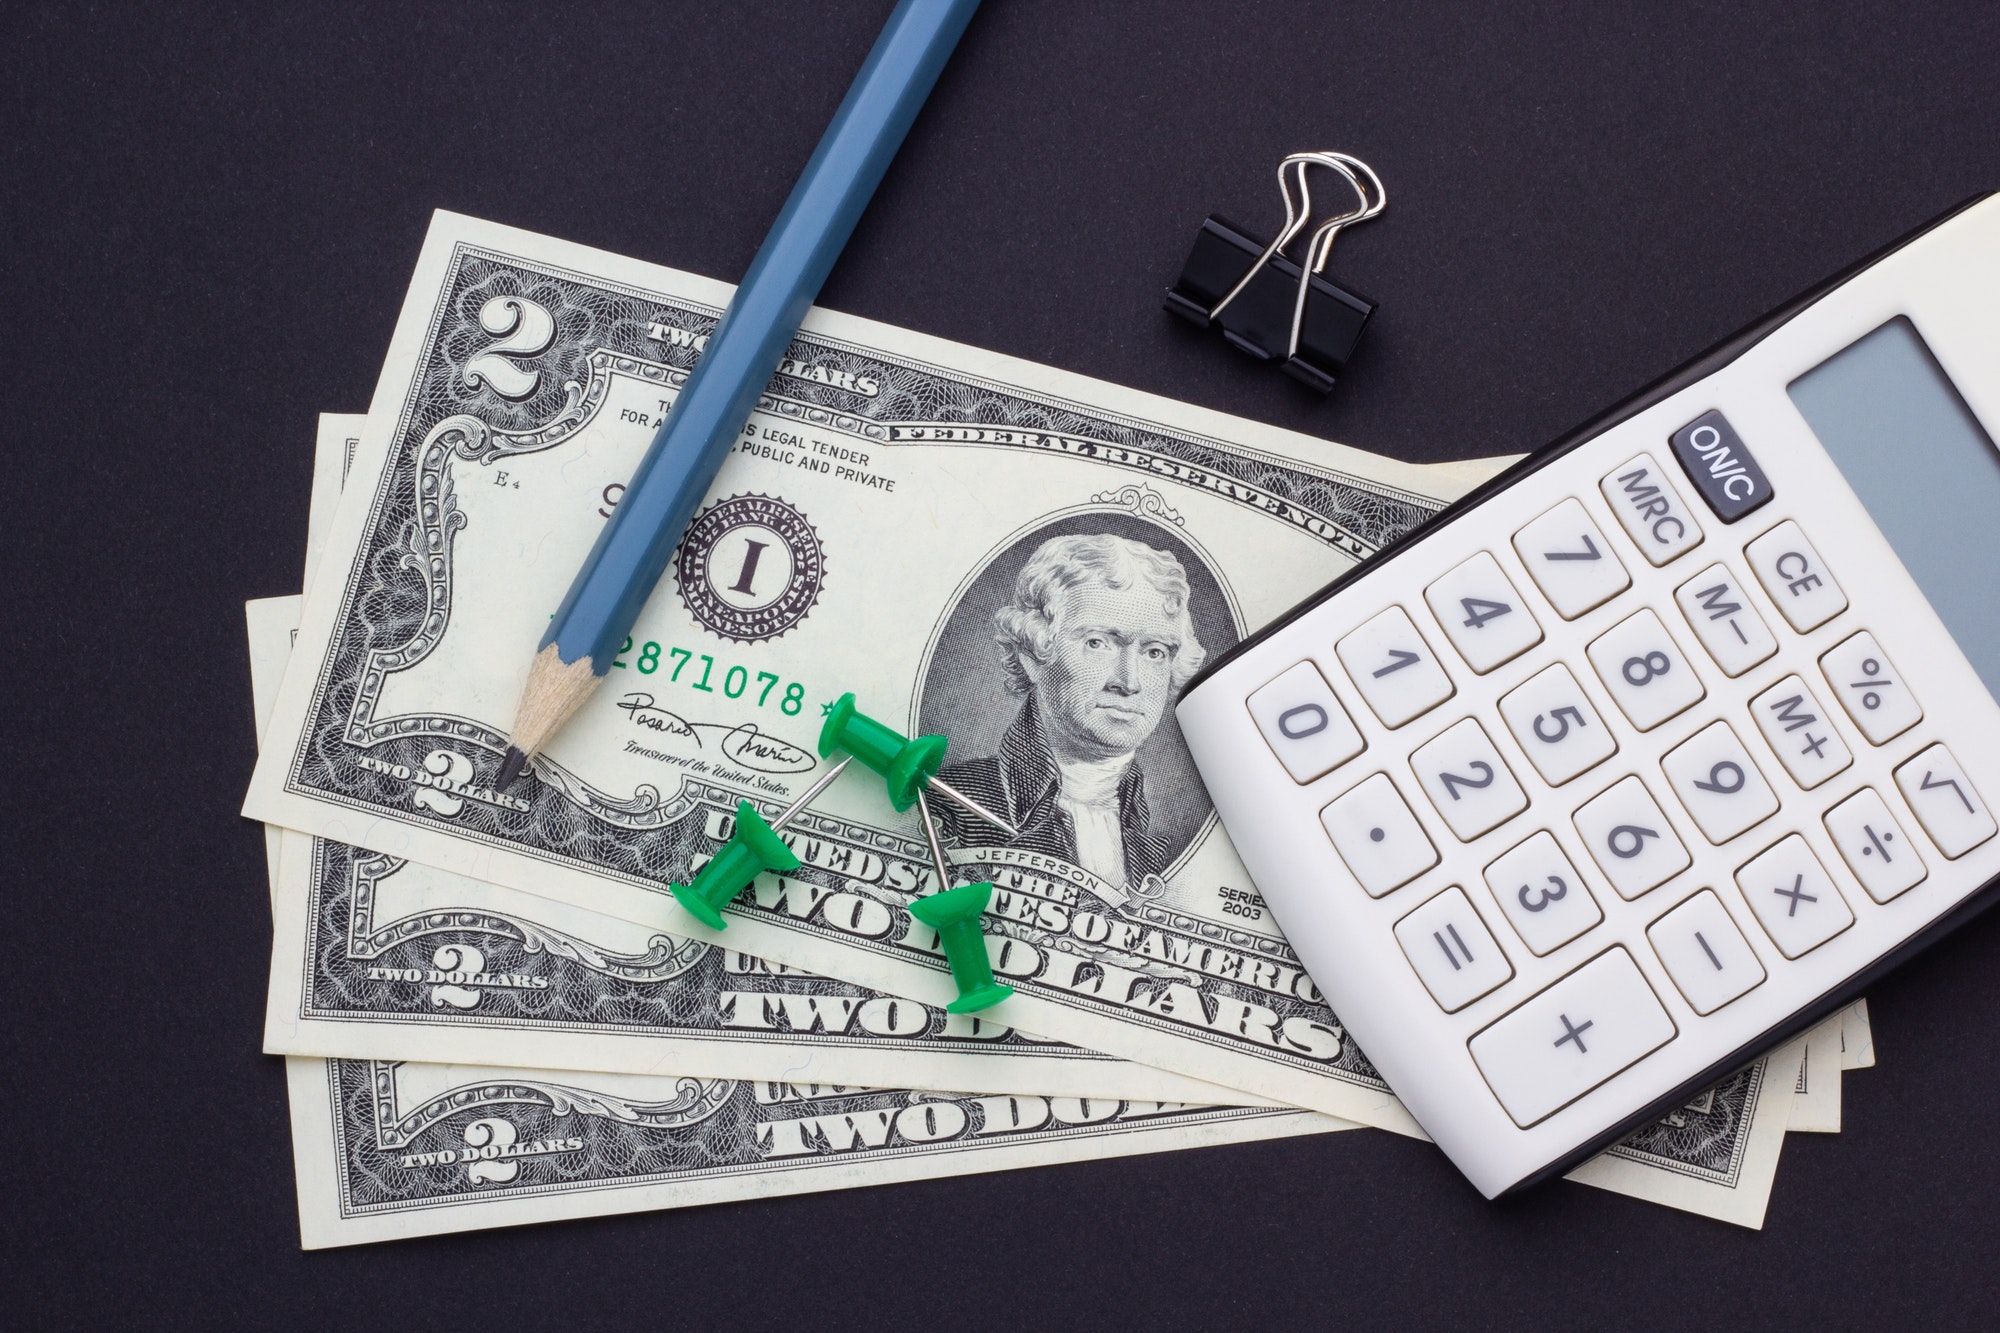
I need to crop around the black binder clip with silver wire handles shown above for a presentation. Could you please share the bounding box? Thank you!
[1166,152,1388,394]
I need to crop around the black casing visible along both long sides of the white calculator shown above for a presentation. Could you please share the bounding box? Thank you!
[1182,190,2000,1197]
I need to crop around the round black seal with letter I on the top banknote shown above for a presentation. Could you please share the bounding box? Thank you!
[674,494,826,642]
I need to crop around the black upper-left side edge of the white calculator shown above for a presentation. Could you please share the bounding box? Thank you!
[1180,190,2000,699]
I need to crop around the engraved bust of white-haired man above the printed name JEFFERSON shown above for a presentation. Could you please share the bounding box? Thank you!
[932,532,1206,889]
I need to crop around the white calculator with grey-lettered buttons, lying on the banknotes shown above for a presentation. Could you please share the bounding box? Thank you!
[1178,196,2000,1197]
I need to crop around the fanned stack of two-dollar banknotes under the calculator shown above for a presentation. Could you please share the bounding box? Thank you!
[244,214,1874,1247]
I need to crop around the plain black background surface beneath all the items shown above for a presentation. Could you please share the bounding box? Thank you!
[0,0,2000,1329]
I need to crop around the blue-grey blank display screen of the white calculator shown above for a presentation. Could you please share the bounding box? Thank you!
[1788,316,2000,699]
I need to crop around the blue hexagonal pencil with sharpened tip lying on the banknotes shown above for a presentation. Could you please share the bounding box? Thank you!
[496,0,978,787]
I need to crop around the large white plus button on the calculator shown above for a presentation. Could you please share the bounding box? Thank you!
[1468,949,1674,1129]
